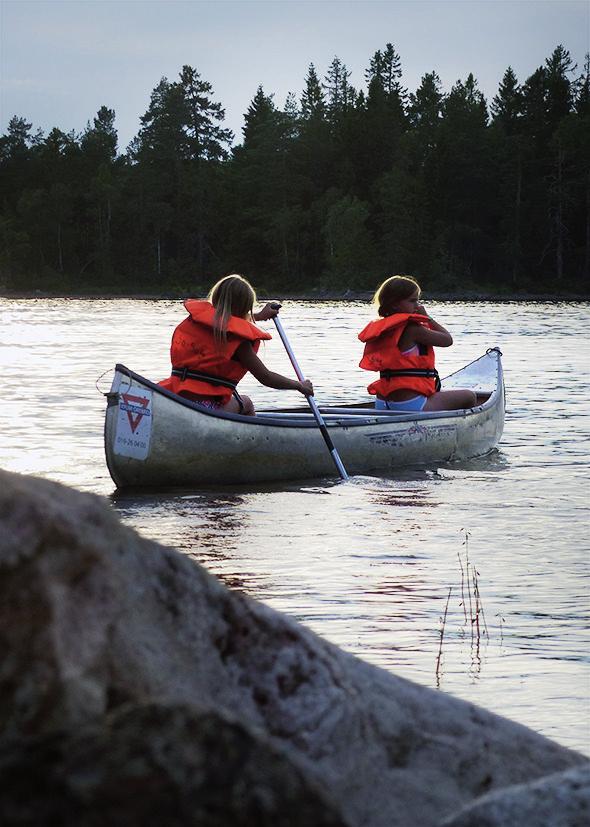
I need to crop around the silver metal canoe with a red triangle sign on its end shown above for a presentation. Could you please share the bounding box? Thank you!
[105,348,505,488]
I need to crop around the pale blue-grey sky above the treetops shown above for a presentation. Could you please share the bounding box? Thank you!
[0,0,590,151]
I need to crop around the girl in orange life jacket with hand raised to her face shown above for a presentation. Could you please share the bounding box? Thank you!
[359,276,477,412]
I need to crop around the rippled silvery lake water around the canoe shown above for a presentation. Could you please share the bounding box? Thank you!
[0,299,590,755]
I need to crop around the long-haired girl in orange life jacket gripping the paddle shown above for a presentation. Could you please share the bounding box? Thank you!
[159,275,313,416]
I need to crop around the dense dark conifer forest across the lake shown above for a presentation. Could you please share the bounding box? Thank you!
[0,44,590,295]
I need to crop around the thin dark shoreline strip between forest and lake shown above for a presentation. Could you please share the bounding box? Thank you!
[0,290,590,304]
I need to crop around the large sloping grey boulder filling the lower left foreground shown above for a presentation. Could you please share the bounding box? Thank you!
[0,473,585,827]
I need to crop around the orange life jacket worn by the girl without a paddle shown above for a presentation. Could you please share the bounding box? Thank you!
[359,313,440,399]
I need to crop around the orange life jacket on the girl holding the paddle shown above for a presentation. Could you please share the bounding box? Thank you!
[159,299,272,405]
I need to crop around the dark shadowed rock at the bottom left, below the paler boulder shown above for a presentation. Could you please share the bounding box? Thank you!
[0,704,346,827]
